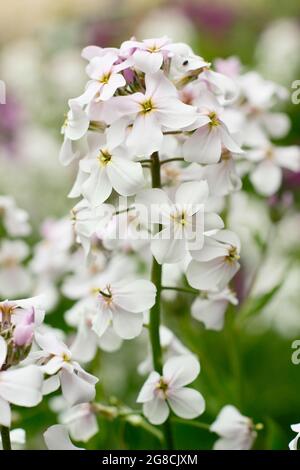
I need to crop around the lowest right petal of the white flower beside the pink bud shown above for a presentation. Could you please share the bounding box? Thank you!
[59,370,96,406]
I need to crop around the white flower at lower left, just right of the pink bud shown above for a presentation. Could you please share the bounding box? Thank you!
[32,333,98,406]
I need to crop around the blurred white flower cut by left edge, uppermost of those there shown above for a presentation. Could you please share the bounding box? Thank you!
[0,196,31,237]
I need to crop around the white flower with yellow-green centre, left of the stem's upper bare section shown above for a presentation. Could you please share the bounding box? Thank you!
[81,133,144,205]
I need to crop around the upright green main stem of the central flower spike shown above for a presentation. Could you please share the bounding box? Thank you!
[149,152,174,450]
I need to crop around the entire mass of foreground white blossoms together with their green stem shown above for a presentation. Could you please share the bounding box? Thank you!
[0,37,300,450]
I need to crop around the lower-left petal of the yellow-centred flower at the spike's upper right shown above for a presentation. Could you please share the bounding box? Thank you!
[183,126,221,163]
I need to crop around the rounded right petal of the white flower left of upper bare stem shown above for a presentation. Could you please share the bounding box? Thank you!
[107,155,144,196]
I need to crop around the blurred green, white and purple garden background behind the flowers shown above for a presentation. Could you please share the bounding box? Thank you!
[0,0,300,449]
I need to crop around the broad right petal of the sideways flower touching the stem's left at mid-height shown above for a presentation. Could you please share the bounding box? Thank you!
[112,279,156,313]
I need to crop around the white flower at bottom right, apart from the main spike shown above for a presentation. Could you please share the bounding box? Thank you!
[210,405,256,450]
